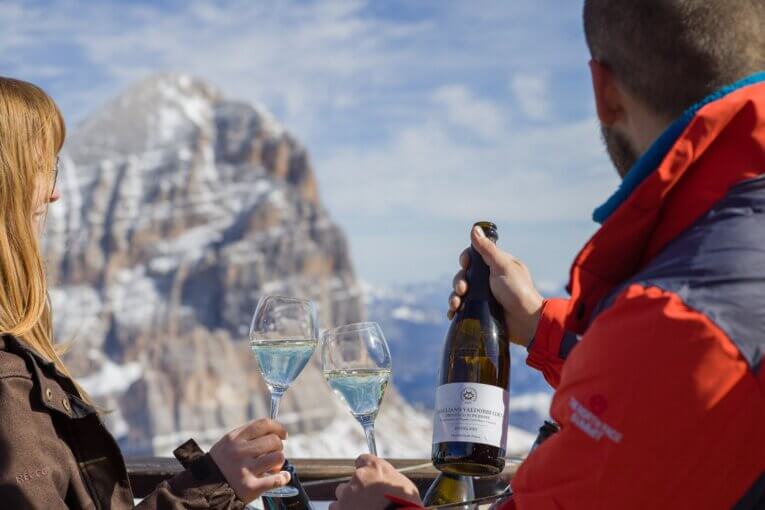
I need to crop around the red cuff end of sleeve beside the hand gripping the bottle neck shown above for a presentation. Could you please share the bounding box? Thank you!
[526,299,577,388]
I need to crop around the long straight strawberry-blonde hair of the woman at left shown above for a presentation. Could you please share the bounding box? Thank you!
[0,77,69,375]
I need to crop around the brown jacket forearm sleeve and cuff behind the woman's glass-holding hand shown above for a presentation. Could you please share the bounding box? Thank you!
[136,439,245,510]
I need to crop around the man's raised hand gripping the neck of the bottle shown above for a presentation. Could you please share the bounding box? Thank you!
[448,227,544,347]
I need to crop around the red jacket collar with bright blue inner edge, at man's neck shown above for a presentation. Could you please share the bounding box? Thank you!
[566,73,765,333]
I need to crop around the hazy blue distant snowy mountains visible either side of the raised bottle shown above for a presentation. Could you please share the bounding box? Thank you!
[364,276,552,436]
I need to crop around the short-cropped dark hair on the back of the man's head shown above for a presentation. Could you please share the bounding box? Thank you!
[584,0,765,117]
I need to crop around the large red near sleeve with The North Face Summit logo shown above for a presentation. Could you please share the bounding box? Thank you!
[507,285,765,510]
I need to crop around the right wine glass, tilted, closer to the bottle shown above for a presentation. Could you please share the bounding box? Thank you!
[321,322,391,455]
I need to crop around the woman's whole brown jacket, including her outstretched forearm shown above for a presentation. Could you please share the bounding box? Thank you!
[0,335,244,510]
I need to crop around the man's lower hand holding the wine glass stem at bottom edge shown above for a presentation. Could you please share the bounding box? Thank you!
[329,454,422,510]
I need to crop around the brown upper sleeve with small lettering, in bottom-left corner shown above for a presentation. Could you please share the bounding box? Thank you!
[0,374,71,509]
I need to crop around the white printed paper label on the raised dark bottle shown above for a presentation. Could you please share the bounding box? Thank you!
[433,383,509,449]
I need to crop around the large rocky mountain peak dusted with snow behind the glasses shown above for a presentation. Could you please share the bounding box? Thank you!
[44,74,429,455]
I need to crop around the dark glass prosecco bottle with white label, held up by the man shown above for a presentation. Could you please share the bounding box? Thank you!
[432,222,510,476]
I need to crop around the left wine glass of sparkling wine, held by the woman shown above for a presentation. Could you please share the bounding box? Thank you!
[250,296,319,498]
